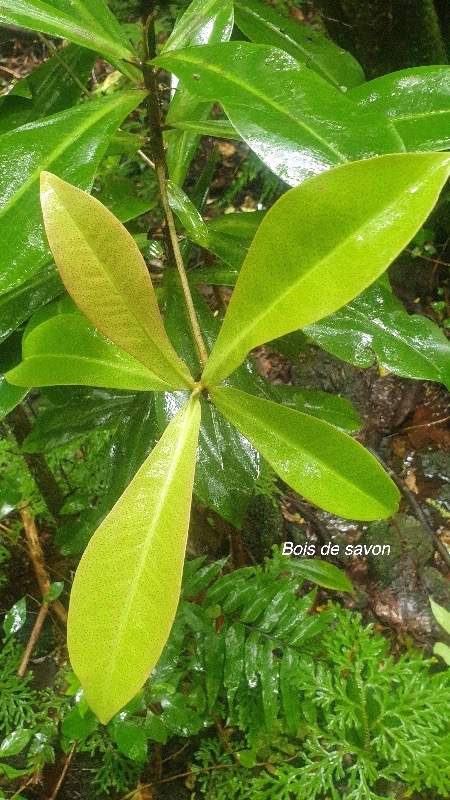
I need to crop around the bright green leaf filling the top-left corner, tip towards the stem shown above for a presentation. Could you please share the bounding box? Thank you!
[0,0,133,61]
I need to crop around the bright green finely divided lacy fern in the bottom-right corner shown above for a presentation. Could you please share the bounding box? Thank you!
[193,607,450,800]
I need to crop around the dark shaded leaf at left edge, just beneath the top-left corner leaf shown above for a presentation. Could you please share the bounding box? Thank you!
[0,44,95,134]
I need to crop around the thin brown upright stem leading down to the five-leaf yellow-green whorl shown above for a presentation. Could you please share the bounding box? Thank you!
[142,14,208,366]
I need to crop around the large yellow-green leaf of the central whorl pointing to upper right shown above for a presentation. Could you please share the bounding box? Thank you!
[203,153,450,385]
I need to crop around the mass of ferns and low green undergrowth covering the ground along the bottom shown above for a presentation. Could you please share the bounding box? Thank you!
[0,548,450,800]
